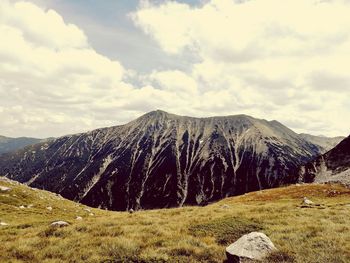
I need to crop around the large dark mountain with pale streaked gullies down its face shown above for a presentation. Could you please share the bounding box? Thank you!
[0,110,336,210]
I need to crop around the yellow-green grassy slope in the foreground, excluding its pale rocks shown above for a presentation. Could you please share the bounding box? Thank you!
[0,180,350,263]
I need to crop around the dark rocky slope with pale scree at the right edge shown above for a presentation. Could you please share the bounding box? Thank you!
[299,136,350,184]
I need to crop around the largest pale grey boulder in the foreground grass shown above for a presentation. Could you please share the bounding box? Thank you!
[226,232,276,263]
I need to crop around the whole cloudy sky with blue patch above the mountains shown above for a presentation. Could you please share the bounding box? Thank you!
[0,0,350,138]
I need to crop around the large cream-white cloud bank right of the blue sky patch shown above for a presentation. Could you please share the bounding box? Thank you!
[131,0,350,135]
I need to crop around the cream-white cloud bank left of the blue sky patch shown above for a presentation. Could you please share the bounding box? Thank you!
[0,1,183,137]
